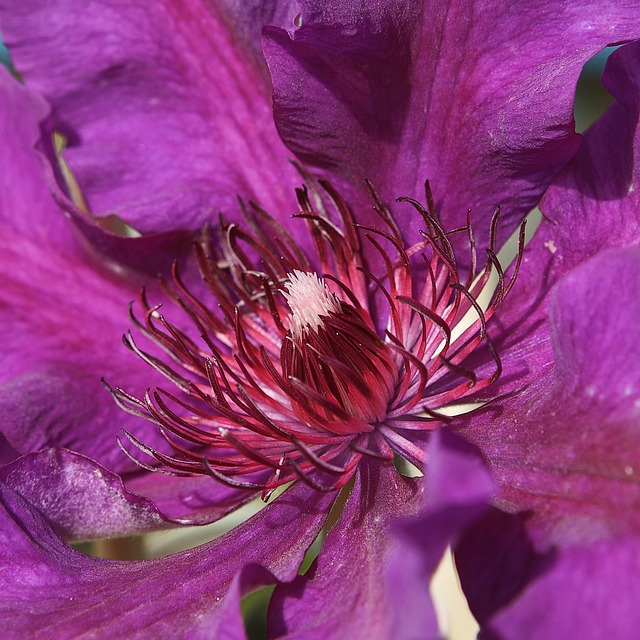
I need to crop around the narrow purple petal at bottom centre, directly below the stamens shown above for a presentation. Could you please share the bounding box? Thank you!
[269,464,420,640]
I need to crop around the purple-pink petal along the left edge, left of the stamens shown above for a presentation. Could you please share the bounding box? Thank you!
[0,69,154,470]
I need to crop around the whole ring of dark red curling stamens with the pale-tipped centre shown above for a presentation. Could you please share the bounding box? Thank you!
[110,182,524,499]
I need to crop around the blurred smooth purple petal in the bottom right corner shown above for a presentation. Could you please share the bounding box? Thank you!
[482,537,640,640]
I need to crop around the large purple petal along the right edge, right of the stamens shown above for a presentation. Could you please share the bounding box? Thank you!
[461,44,640,541]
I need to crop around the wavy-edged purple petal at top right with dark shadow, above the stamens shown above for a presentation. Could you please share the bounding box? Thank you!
[264,0,638,236]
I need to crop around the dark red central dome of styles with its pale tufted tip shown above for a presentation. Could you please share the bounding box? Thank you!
[280,271,397,433]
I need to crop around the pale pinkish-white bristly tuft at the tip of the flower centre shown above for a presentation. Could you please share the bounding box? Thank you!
[284,269,340,340]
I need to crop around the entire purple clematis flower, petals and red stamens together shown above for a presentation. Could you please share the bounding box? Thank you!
[0,2,638,638]
